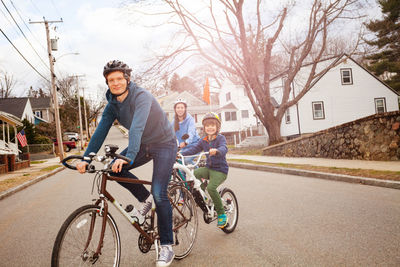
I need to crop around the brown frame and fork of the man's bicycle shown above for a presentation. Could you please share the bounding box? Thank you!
[85,172,189,257]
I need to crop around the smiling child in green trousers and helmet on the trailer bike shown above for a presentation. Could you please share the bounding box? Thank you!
[180,112,229,228]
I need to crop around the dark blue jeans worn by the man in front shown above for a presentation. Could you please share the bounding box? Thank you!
[113,140,177,245]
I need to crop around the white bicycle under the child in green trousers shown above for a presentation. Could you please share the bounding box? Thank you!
[170,152,239,234]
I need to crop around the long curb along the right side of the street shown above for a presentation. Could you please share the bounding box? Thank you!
[228,162,400,192]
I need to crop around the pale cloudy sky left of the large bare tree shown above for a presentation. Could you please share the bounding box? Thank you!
[0,0,379,100]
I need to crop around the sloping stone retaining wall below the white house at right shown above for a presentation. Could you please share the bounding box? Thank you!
[263,111,400,160]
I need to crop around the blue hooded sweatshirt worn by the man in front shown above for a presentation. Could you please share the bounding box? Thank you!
[84,82,175,162]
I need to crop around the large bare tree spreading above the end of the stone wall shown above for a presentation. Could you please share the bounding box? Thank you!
[130,0,366,144]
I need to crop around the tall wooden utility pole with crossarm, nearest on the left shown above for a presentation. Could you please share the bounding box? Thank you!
[29,17,64,162]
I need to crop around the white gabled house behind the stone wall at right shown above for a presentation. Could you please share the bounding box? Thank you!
[271,55,399,138]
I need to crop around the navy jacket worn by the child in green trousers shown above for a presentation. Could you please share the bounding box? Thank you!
[181,134,229,174]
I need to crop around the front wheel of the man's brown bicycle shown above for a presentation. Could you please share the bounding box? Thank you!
[51,205,121,267]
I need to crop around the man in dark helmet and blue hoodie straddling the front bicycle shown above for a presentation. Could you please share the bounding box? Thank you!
[76,60,177,266]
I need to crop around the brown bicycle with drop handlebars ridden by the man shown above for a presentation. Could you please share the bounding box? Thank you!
[51,145,198,267]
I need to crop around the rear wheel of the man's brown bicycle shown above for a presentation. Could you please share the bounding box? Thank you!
[168,185,199,260]
